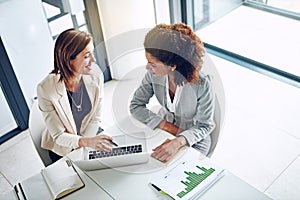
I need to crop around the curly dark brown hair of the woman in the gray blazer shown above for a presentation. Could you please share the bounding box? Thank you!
[144,22,205,85]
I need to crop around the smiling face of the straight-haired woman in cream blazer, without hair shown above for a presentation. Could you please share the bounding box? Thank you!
[70,42,96,75]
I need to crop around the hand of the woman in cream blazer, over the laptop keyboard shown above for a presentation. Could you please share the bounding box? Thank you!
[78,134,112,152]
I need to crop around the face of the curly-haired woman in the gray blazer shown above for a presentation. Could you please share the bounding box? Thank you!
[145,52,174,76]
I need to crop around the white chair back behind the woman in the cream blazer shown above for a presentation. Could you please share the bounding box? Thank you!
[28,99,52,166]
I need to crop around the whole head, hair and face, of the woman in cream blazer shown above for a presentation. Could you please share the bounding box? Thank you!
[51,28,95,85]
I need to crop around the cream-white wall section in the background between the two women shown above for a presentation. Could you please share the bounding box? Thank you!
[97,0,155,79]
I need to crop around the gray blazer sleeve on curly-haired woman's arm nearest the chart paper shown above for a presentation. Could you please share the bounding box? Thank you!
[178,75,215,146]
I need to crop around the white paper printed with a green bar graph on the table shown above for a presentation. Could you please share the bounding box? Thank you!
[151,151,224,200]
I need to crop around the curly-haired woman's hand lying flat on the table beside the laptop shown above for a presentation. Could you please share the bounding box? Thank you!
[151,136,187,162]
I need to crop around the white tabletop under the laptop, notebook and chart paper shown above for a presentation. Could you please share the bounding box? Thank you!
[0,118,271,200]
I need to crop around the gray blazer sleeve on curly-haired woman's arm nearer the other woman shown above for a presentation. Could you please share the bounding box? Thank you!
[130,71,163,129]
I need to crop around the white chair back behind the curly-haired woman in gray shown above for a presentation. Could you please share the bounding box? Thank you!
[202,54,225,157]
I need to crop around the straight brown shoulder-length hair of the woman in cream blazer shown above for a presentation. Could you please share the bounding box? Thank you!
[51,28,92,82]
